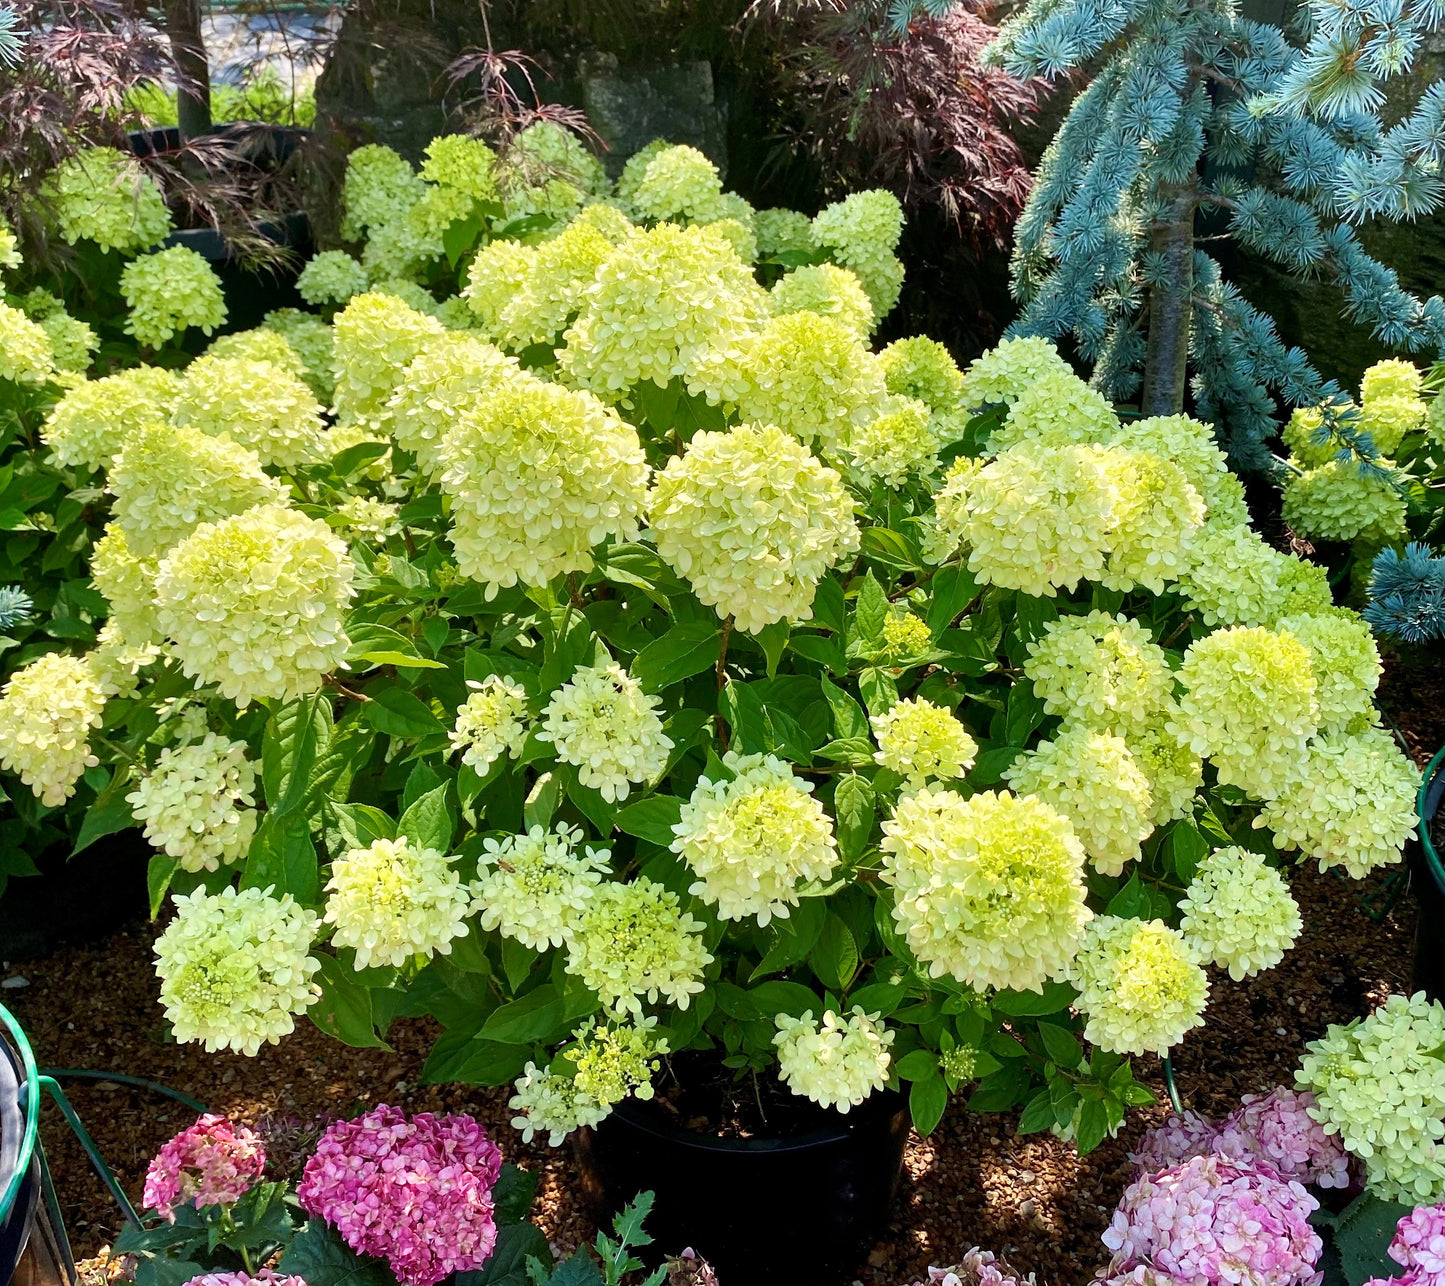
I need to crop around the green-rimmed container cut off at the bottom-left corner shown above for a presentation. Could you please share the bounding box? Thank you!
[0,1009,75,1286]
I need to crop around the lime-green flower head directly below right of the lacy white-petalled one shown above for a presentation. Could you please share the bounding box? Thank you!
[566,876,712,1016]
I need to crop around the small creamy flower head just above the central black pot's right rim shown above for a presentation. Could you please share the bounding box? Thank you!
[773,1004,893,1113]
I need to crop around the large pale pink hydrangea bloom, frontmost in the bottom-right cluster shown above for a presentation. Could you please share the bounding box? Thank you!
[1100,1153,1324,1286]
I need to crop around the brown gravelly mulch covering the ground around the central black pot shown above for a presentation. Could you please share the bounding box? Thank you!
[0,660,1445,1286]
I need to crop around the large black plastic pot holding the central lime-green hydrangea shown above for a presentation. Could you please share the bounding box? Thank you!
[574,1091,909,1286]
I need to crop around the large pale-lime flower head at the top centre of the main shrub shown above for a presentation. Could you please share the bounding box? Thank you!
[558,224,767,402]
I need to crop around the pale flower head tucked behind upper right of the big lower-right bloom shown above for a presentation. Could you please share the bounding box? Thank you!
[1004,724,1153,876]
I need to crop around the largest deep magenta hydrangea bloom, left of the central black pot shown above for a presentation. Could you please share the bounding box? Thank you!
[296,1104,501,1286]
